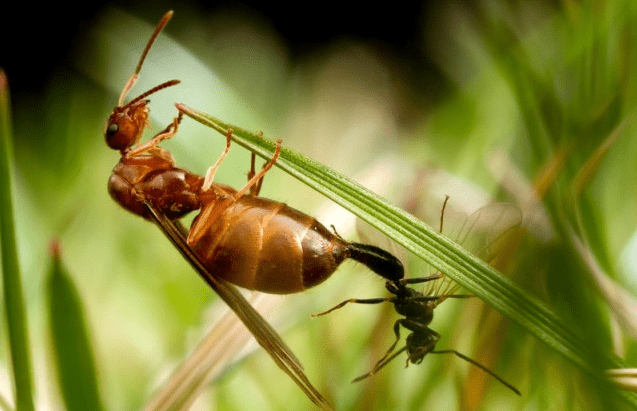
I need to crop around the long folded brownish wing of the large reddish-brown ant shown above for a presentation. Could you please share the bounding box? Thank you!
[147,203,333,410]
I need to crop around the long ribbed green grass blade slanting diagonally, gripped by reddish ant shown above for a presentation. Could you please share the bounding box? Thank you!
[177,104,637,407]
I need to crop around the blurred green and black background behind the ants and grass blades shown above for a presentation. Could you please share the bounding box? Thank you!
[0,0,637,410]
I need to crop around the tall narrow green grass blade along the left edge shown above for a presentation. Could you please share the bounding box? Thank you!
[0,69,34,411]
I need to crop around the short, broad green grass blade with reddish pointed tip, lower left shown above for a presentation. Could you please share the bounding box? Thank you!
[46,244,104,411]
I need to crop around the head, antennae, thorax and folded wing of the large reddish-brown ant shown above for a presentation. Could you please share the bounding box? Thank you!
[104,11,332,410]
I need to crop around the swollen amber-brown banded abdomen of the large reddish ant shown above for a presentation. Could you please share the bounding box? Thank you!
[193,195,349,294]
